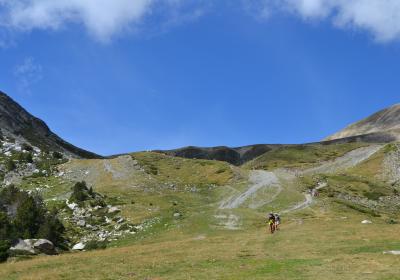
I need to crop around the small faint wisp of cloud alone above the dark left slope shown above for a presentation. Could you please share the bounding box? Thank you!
[14,57,43,94]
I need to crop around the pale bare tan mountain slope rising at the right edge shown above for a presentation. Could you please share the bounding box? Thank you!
[325,104,400,141]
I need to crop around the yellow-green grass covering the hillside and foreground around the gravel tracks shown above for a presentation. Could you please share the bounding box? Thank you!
[0,146,400,280]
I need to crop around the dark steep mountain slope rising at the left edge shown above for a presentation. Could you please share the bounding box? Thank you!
[0,91,100,158]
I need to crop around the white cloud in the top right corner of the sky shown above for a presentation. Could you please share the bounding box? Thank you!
[262,0,400,42]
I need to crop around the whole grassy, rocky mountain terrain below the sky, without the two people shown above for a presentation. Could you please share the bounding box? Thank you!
[0,93,400,280]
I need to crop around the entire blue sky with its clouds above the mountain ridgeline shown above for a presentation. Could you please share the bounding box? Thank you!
[0,0,400,155]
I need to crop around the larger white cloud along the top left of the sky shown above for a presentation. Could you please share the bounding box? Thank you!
[0,0,189,42]
